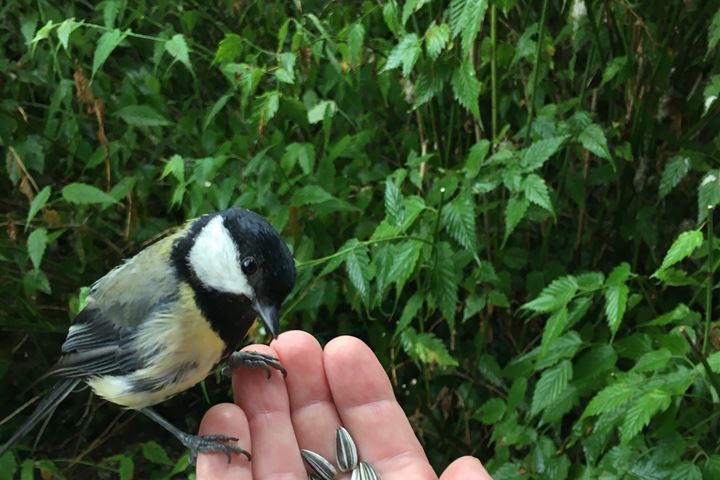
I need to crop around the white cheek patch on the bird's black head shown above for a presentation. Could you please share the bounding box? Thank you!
[188,216,255,299]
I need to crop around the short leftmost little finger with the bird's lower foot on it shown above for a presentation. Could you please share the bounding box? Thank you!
[197,403,252,480]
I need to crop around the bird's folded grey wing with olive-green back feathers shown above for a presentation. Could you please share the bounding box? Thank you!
[51,236,178,377]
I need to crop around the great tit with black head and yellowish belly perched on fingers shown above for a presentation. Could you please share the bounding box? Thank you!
[0,208,295,459]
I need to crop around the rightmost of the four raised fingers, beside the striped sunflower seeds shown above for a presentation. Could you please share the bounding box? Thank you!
[323,337,437,480]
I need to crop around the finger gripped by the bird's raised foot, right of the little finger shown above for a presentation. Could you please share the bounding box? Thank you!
[233,345,307,478]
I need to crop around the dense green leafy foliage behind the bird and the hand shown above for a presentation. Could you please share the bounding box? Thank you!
[0,0,720,480]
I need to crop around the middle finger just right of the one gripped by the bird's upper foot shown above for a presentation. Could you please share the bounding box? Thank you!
[272,330,340,461]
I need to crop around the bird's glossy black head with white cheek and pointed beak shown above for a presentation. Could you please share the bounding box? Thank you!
[186,208,295,338]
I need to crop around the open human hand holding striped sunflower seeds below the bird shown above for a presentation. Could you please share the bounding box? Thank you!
[197,331,492,480]
